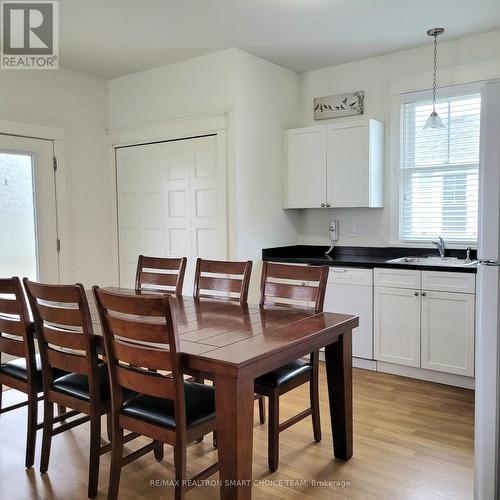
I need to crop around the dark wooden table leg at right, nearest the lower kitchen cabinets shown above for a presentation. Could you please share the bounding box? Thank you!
[325,330,352,460]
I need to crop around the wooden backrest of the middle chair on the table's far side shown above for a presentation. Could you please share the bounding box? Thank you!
[193,259,252,304]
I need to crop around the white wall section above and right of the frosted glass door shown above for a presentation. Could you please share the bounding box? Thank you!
[0,69,113,285]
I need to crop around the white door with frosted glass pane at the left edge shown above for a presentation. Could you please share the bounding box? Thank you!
[0,134,59,283]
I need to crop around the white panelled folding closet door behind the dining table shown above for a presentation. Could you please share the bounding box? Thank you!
[116,136,227,294]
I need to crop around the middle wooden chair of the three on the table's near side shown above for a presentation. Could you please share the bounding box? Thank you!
[23,278,118,498]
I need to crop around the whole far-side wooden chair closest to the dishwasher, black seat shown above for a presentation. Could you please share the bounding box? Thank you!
[255,262,329,471]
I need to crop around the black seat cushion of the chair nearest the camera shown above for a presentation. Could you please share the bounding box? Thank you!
[122,382,215,429]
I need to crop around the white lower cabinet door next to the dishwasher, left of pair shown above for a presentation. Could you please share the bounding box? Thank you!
[373,287,421,367]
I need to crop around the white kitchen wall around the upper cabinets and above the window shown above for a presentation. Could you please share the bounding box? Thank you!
[298,31,500,246]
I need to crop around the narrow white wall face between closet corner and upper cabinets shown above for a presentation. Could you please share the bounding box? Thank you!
[235,51,298,300]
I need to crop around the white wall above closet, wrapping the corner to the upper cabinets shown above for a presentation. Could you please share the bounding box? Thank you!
[109,49,298,298]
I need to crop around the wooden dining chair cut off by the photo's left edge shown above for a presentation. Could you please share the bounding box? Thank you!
[0,278,43,468]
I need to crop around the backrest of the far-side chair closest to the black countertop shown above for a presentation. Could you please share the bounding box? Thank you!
[260,262,329,312]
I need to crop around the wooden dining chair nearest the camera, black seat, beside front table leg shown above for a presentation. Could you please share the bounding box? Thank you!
[93,286,218,500]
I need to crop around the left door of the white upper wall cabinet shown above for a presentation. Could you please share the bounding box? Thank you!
[284,127,326,208]
